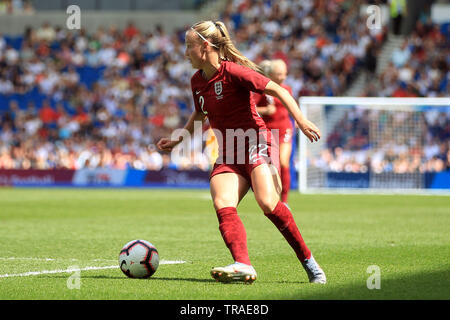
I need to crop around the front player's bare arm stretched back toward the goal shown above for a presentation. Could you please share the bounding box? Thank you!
[264,81,320,142]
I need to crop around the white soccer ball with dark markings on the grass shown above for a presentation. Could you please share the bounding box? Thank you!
[119,240,159,278]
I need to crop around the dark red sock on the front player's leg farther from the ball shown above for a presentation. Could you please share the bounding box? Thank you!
[264,201,311,262]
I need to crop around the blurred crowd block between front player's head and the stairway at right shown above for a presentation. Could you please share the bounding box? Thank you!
[221,0,387,98]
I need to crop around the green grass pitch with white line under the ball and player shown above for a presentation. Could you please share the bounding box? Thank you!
[0,188,450,300]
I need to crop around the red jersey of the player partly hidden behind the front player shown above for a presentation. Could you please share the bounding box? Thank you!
[254,84,292,129]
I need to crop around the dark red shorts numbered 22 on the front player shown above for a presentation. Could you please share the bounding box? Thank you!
[210,127,280,185]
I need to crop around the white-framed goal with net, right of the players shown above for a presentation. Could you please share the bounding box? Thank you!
[296,97,450,193]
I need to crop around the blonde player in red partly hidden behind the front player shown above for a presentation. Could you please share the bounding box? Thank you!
[255,59,293,204]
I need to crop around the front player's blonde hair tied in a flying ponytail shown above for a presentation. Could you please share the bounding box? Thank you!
[191,21,263,73]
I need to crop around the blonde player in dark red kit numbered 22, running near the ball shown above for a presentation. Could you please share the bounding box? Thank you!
[157,21,326,283]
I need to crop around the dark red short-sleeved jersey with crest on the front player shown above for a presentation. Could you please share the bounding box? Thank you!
[191,61,271,169]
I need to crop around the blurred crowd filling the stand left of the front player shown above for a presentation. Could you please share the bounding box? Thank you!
[0,23,202,169]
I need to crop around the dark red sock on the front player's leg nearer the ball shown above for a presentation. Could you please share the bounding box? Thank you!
[216,207,251,265]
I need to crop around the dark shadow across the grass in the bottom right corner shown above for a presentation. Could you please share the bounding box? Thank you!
[277,270,450,300]
